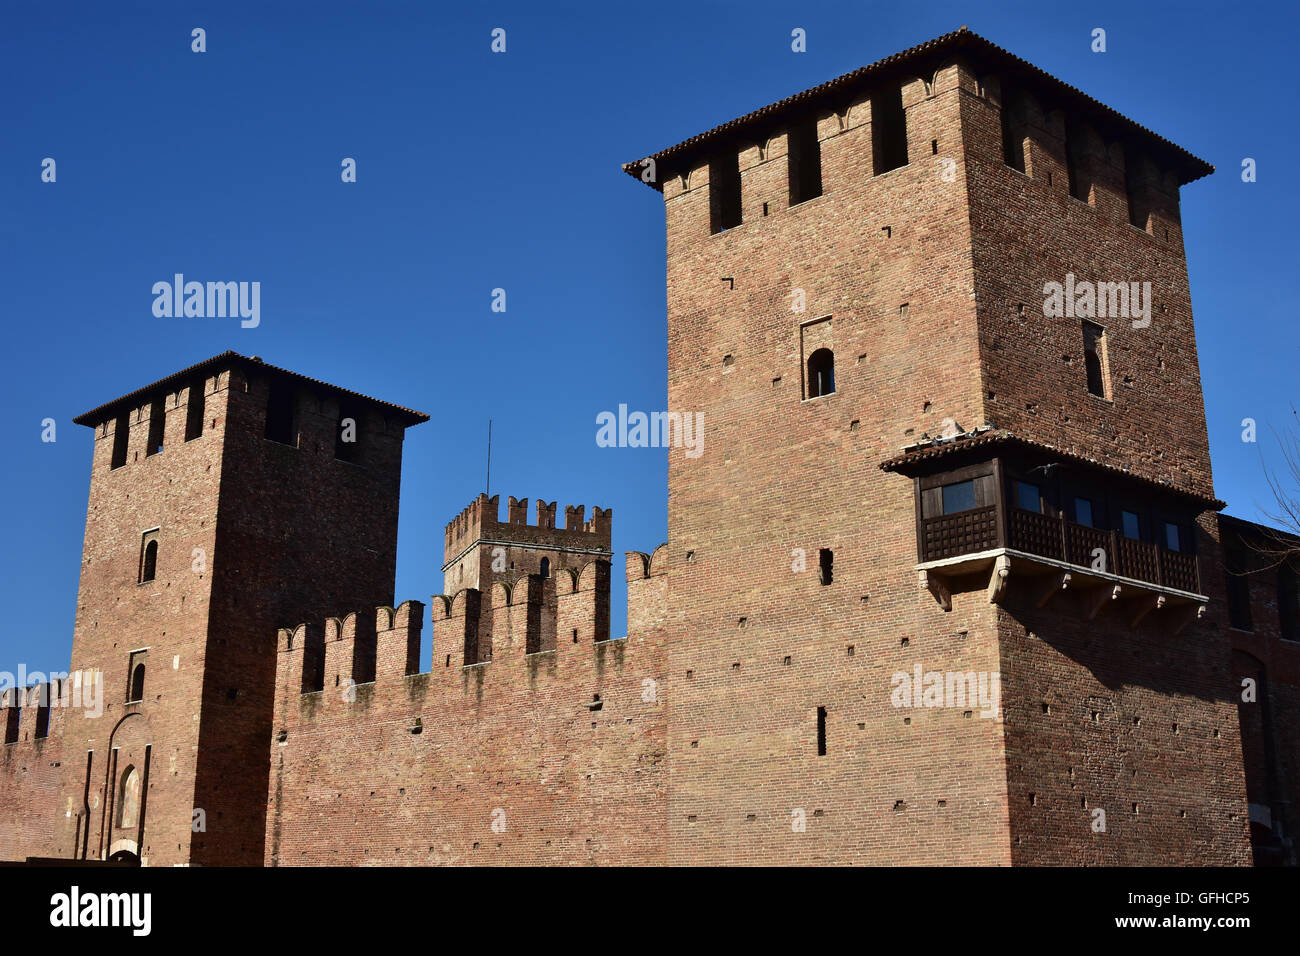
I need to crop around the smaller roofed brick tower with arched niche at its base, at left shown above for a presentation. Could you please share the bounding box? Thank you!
[49,352,428,865]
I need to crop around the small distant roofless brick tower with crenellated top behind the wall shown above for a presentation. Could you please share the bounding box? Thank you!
[442,493,614,661]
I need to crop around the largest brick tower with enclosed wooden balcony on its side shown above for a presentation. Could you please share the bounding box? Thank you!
[625,27,1249,864]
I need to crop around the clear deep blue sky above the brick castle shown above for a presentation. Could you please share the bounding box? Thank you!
[0,0,1300,670]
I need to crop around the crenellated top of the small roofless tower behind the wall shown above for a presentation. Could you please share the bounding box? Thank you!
[443,493,614,563]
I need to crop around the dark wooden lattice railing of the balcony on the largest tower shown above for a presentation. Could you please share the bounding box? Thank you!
[920,506,1200,593]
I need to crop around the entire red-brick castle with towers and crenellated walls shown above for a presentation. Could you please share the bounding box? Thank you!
[0,27,1300,865]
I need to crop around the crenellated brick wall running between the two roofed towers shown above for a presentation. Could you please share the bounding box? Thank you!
[267,561,667,865]
